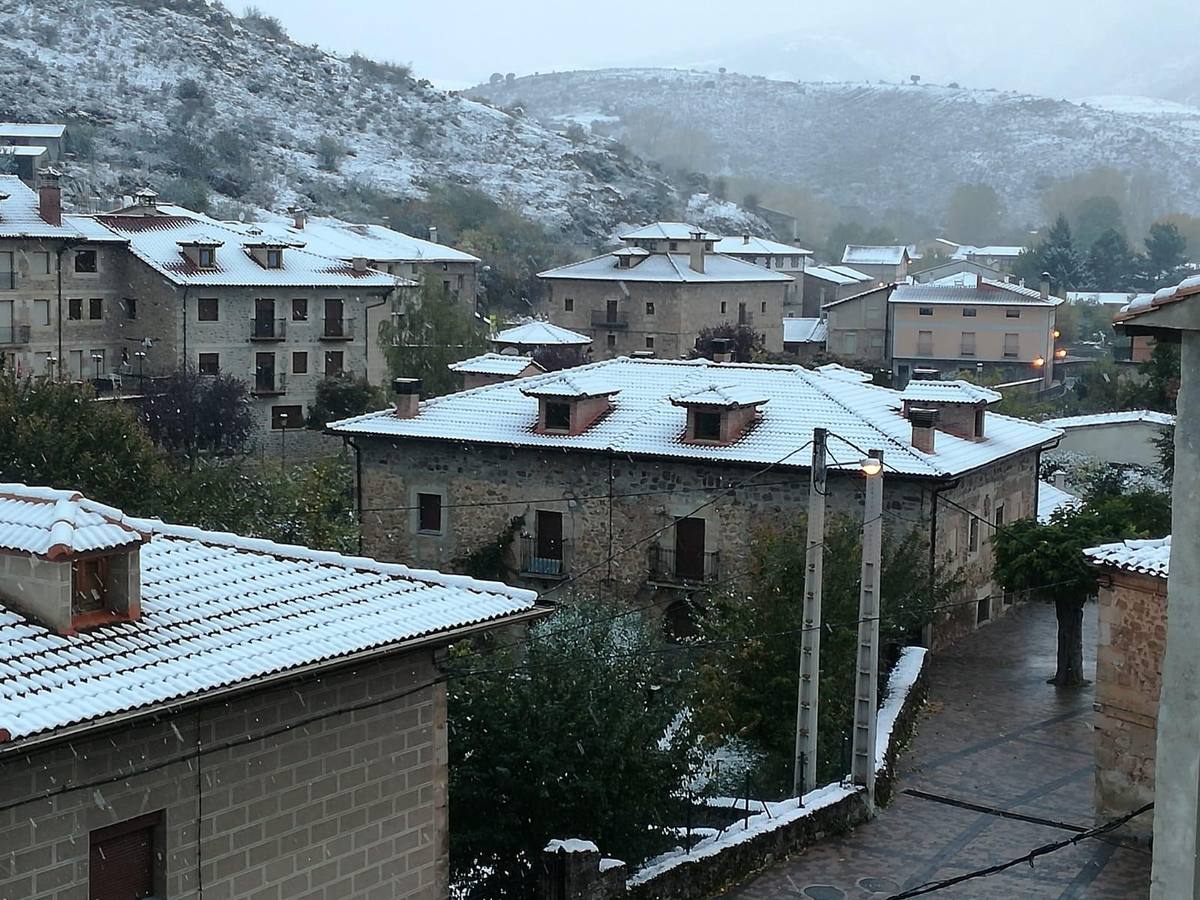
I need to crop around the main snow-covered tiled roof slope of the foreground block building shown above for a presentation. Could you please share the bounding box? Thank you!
[0,501,536,740]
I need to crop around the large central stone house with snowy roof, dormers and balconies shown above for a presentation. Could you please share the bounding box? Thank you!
[330,358,1058,640]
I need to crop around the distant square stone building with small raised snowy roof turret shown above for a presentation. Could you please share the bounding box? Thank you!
[538,222,796,359]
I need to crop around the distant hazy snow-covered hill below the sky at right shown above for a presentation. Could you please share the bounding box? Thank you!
[476,68,1200,224]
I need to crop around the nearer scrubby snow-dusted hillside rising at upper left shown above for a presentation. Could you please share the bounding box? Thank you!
[0,0,668,239]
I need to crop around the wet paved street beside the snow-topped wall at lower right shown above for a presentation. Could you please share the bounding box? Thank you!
[725,604,1150,900]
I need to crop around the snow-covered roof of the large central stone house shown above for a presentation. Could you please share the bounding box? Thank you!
[329,358,1061,487]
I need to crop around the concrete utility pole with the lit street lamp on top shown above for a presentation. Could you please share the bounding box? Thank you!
[850,450,883,815]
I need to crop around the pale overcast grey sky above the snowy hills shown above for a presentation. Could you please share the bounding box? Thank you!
[241,0,1200,98]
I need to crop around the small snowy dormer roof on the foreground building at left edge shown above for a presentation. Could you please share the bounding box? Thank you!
[0,484,145,559]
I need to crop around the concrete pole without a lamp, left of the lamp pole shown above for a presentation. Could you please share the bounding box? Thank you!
[792,428,828,797]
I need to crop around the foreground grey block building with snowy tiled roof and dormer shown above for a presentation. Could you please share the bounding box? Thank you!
[0,485,546,900]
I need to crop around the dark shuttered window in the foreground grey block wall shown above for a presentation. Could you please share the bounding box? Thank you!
[88,812,167,898]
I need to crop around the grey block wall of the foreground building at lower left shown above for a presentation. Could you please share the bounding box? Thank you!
[0,650,449,900]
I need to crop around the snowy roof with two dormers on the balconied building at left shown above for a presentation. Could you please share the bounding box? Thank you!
[95,215,397,290]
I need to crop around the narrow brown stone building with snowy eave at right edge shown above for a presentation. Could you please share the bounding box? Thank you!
[1084,538,1171,841]
